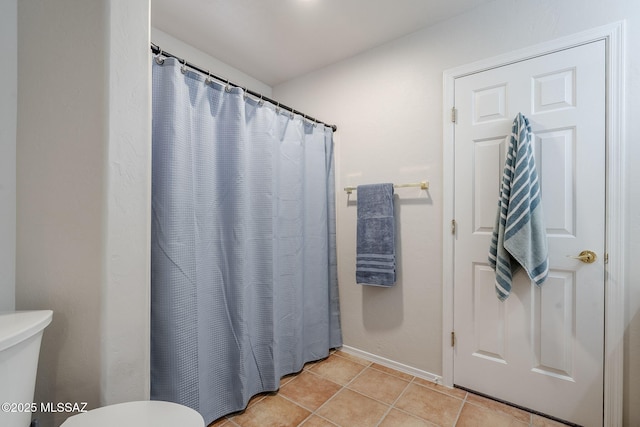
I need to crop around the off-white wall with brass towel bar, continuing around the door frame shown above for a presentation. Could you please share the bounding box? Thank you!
[273,0,640,426]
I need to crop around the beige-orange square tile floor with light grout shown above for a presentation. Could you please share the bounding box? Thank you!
[210,351,562,427]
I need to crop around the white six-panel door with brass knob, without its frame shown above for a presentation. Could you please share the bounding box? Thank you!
[453,41,606,426]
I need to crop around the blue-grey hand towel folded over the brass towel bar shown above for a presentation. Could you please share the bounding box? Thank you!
[356,184,396,286]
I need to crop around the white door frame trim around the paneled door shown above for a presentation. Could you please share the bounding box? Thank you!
[442,21,626,426]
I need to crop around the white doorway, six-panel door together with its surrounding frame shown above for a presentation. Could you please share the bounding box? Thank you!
[443,25,623,425]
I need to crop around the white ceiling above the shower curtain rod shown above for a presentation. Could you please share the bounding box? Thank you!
[151,0,492,86]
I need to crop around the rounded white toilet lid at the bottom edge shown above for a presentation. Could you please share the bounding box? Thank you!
[61,400,204,427]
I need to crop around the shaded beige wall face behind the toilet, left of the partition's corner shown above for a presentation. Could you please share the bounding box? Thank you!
[16,0,106,425]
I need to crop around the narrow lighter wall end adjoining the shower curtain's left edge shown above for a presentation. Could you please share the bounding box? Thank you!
[100,0,151,405]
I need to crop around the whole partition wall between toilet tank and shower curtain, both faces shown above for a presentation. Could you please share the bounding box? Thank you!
[16,0,150,426]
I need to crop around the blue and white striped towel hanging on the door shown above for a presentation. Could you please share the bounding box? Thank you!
[489,113,549,300]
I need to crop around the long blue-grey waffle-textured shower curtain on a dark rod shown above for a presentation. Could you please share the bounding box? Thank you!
[151,58,342,424]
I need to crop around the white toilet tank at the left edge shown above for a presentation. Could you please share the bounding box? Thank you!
[0,310,53,427]
